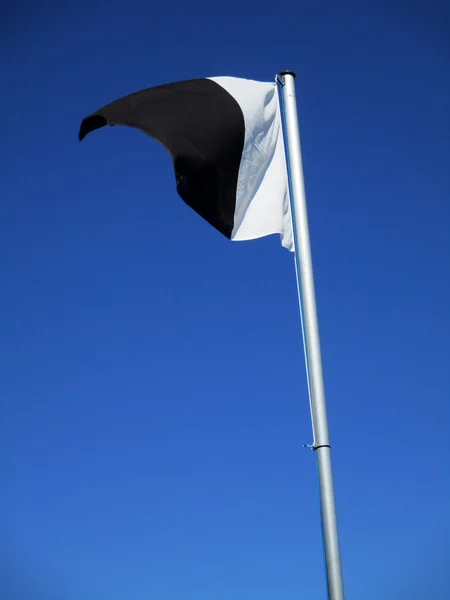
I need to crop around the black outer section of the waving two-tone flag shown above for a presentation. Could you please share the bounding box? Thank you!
[79,79,245,238]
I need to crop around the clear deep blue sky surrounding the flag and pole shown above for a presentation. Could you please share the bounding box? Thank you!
[0,0,450,600]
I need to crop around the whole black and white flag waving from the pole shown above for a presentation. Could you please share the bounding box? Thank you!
[79,77,294,251]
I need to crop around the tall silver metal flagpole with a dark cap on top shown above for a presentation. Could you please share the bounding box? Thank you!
[277,71,344,600]
